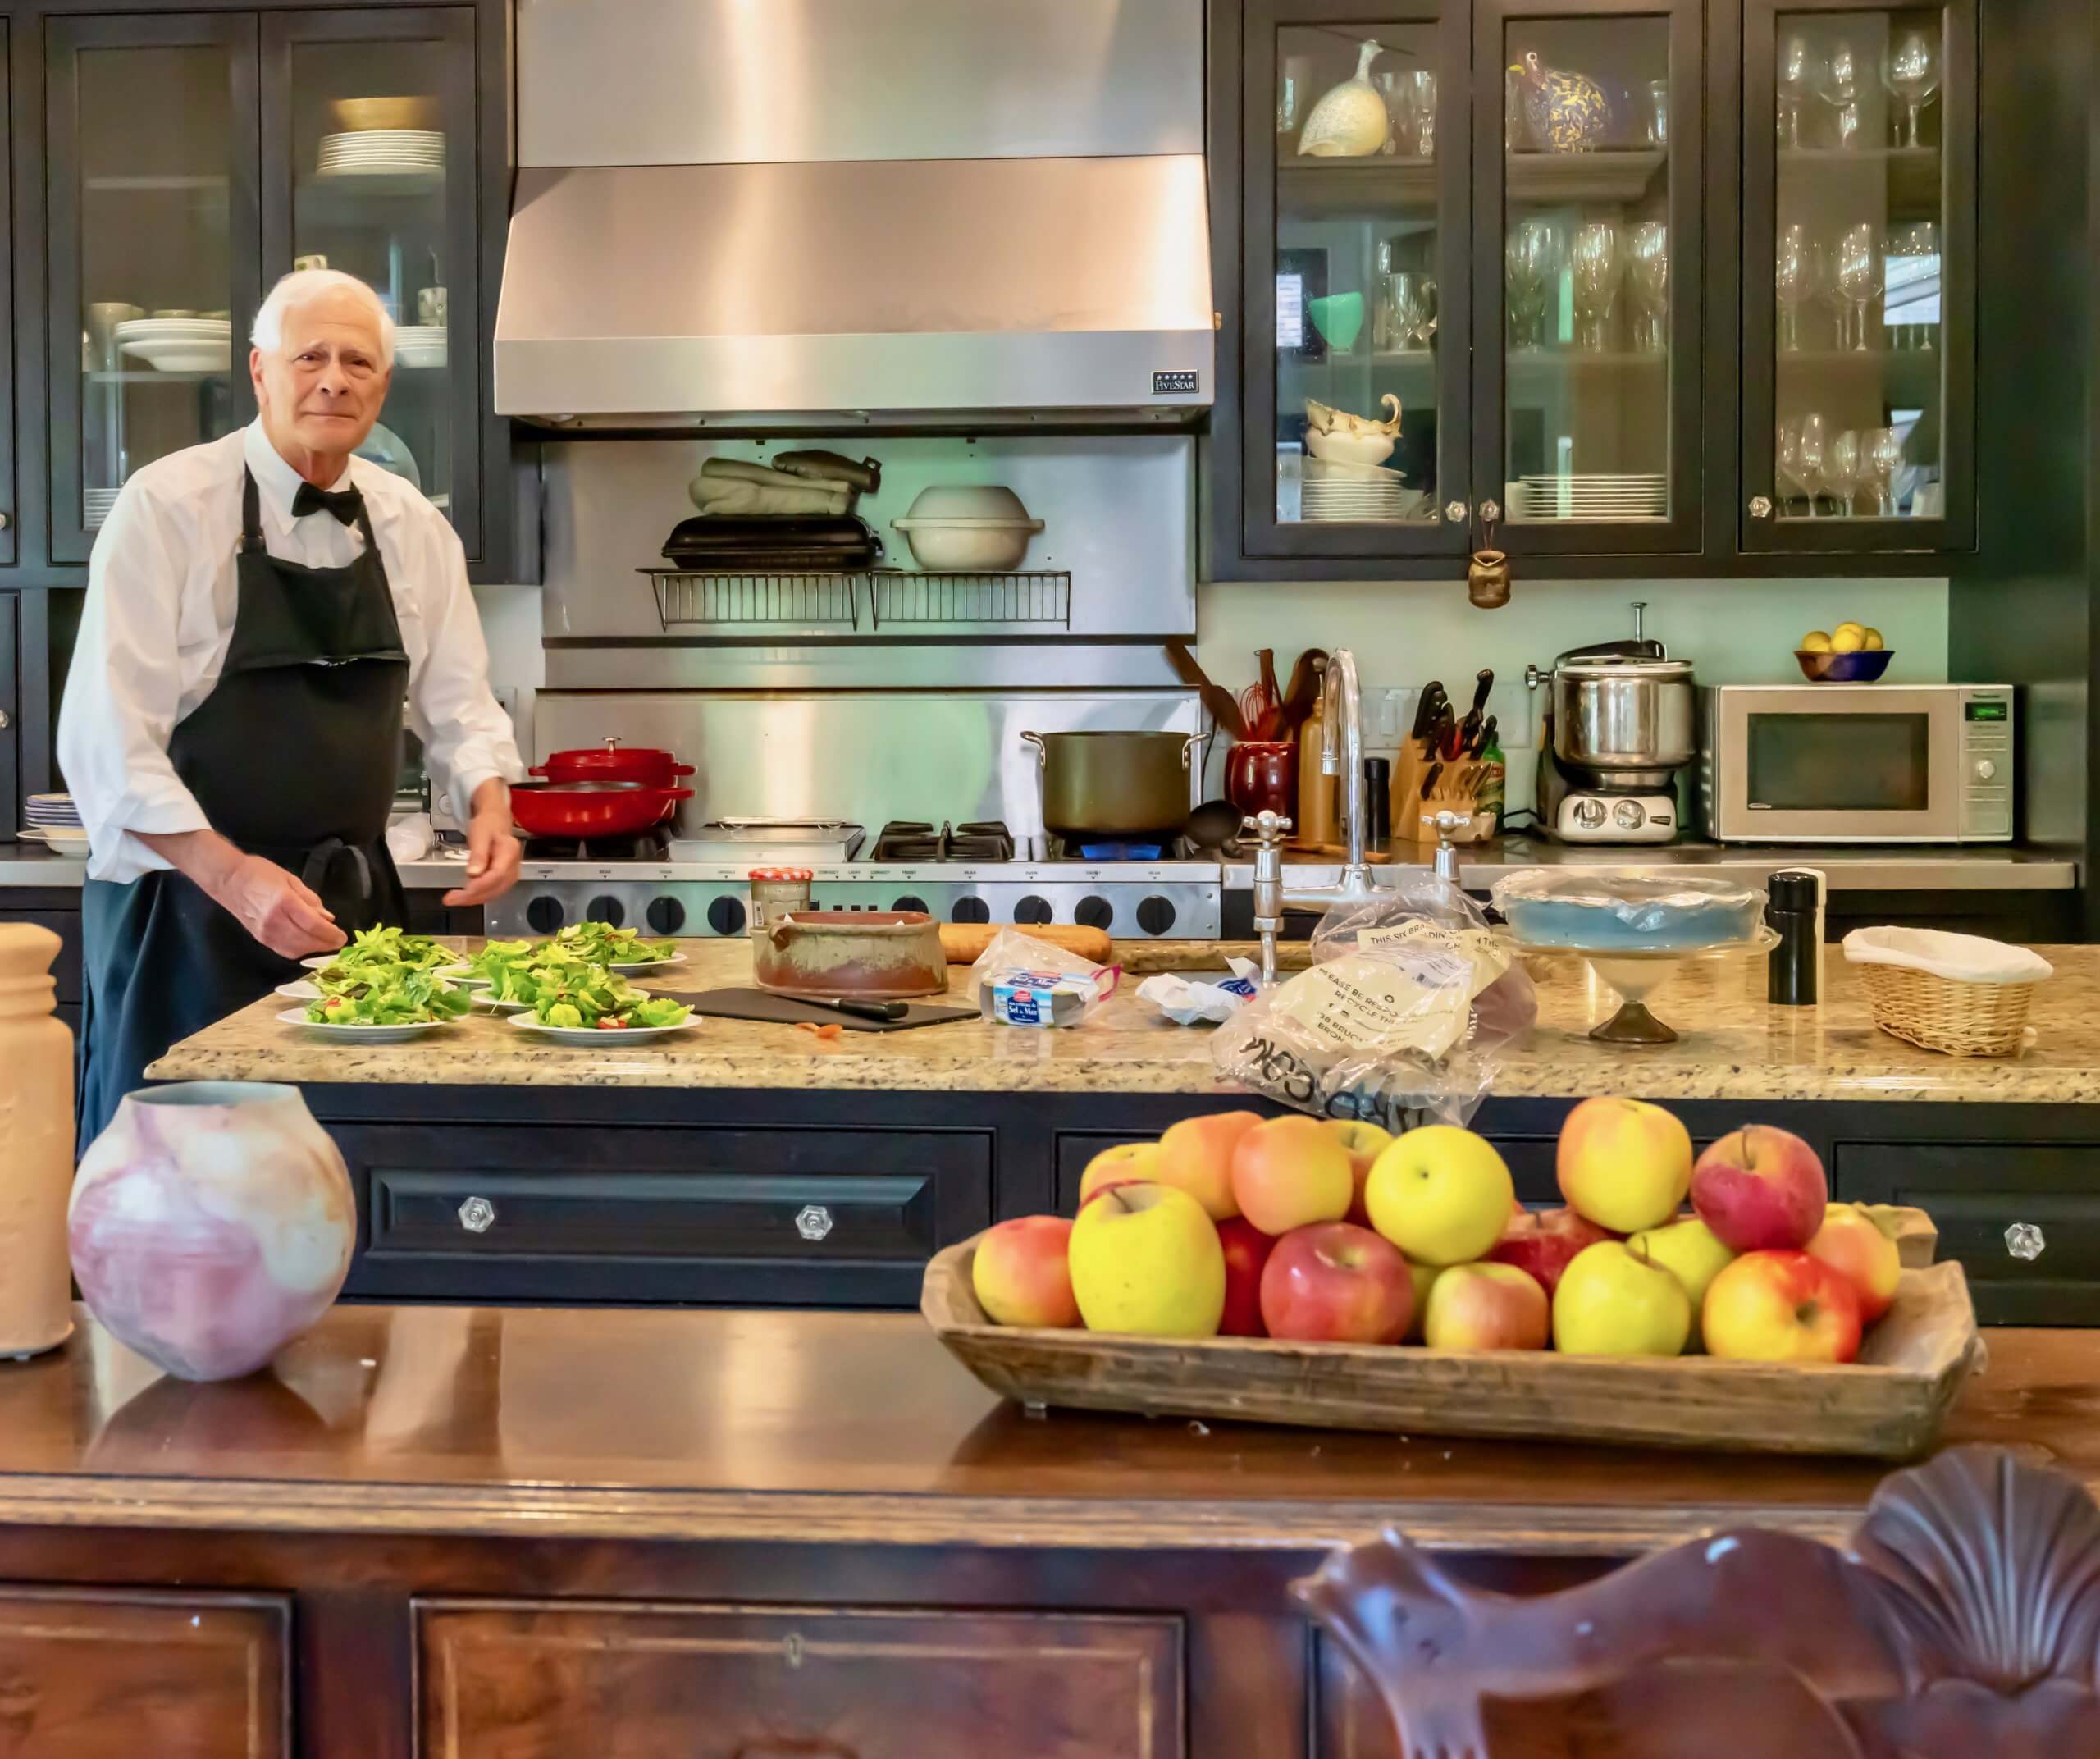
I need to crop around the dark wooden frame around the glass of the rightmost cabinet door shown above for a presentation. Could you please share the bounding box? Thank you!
[1737,0,1974,560]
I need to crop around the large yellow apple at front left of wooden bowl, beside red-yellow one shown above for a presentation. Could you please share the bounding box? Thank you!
[1071,1181,1224,1337]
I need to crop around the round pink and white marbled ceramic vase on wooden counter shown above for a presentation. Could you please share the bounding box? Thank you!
[69,1081,357,1381]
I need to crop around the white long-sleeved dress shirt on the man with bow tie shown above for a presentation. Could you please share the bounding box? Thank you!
[59,422,525,882]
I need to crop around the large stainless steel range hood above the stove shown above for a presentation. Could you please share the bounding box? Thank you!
[495,0,1216,430]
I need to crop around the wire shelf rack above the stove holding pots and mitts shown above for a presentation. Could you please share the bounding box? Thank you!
[641,569,1071,632]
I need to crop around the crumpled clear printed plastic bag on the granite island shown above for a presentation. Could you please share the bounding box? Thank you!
[1212,871,1539,1131]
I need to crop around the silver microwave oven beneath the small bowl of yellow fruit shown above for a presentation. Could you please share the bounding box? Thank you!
[1699,684,2014,844]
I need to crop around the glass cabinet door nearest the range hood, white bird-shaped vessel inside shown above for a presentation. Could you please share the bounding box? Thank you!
[1241,0,1472,559]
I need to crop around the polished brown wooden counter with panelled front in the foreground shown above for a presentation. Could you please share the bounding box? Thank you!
[0,1305,2100,1759]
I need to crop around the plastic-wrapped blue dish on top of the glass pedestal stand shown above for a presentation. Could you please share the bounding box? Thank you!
[1493,867,1764,953]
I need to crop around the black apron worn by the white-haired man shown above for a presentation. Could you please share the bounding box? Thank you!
[78,473,408,1148]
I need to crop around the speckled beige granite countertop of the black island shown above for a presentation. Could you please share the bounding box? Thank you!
[147,940,2100,1104]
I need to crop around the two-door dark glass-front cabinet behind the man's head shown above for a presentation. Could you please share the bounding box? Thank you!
[46,7,483,563]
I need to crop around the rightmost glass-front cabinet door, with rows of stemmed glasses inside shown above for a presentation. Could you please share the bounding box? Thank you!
[1743,0,1976,552]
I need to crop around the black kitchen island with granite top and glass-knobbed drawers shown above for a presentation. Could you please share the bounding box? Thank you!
[149,940,2100,1324]
